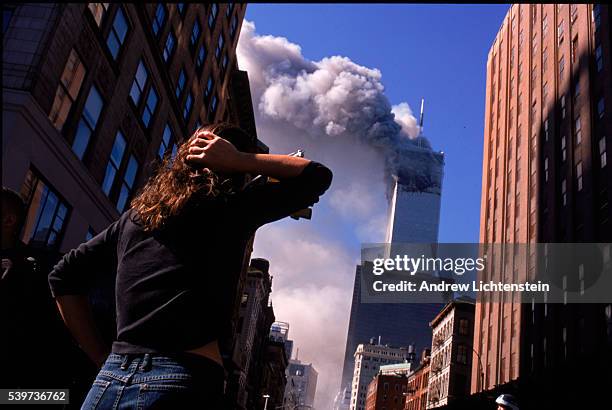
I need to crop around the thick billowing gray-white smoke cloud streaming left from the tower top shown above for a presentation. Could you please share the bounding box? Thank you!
[233,22,433,186]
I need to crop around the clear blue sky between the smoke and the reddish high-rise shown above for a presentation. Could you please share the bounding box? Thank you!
[246,4,509,242]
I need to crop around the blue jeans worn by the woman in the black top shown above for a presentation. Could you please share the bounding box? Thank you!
[81,353,224,410]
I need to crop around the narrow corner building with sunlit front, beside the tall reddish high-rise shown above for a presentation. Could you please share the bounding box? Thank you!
[427,300,474,409]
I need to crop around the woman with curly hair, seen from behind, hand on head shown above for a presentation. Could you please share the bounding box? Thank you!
[49,124,332,409]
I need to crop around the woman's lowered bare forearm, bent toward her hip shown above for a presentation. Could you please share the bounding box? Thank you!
[55,295,110,368]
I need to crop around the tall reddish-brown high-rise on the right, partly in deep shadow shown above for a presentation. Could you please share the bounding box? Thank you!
[471,4,612,394]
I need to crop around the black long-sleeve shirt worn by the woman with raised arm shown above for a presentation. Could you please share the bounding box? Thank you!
[49,161,332,353]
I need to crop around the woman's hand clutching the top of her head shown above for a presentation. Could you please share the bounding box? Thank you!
[186,131,243,173]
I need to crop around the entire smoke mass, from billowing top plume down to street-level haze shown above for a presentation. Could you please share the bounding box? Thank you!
[237,21,431,409]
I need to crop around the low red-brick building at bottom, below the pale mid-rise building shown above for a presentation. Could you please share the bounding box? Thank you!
[365,374,407,410]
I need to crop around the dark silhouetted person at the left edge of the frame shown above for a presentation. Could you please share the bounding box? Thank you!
[0,186,79,389]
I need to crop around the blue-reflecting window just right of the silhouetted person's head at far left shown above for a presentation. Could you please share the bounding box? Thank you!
[22,169,68,248]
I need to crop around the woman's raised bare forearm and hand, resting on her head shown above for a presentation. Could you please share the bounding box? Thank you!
[187,132,310,179]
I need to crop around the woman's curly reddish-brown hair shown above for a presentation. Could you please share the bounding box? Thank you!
[130,123,254,232]
